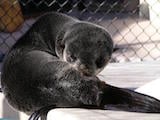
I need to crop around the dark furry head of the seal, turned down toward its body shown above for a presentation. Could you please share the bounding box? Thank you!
[56,22,113,76]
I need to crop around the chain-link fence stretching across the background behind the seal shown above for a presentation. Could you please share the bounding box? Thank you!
[0,0,160,62]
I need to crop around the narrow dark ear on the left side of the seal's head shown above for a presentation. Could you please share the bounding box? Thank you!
[55,31,65,58]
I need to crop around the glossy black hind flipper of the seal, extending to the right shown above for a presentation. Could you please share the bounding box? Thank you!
[101,85,160,113]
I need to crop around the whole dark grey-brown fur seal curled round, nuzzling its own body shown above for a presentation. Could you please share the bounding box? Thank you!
[1,13,160,113]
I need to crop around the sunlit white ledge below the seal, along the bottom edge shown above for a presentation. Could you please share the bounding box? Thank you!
[47,109,160,120]
